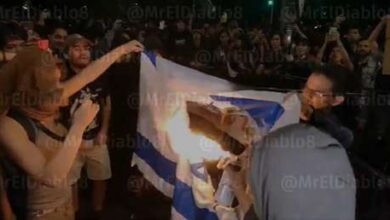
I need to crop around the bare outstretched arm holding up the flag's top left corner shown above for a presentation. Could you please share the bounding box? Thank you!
[60,41,144,98]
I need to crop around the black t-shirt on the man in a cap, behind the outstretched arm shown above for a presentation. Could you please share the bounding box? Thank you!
[62,64,109,140]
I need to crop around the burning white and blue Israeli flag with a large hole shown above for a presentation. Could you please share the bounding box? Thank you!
[133,54,300,220]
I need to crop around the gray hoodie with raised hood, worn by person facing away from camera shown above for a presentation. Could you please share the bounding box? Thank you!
[249,124,356,220]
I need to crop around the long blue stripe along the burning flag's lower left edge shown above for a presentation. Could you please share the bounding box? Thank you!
[135,132,218,220]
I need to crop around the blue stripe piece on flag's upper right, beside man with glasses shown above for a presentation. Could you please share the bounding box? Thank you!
[210,96,284,130]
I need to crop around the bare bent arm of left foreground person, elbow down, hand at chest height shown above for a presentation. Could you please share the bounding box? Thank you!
[0,100,99,186]
